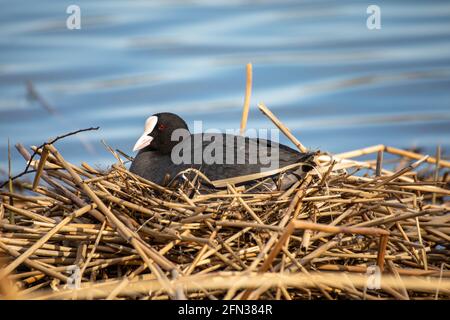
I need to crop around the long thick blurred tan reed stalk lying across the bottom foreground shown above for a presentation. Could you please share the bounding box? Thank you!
[30,272,450,299]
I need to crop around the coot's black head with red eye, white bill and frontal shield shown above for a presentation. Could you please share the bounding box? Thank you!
[133,112,189,154]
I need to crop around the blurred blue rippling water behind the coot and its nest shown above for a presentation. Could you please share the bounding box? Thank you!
[0,0,450,176]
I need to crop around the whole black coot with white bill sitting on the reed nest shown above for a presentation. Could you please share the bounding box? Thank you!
[130,113,313,188]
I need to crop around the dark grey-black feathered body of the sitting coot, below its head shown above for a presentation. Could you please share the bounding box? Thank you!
[130,133,311,183]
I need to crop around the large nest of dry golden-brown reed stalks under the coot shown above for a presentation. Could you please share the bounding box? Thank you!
[0,138,450,300]
